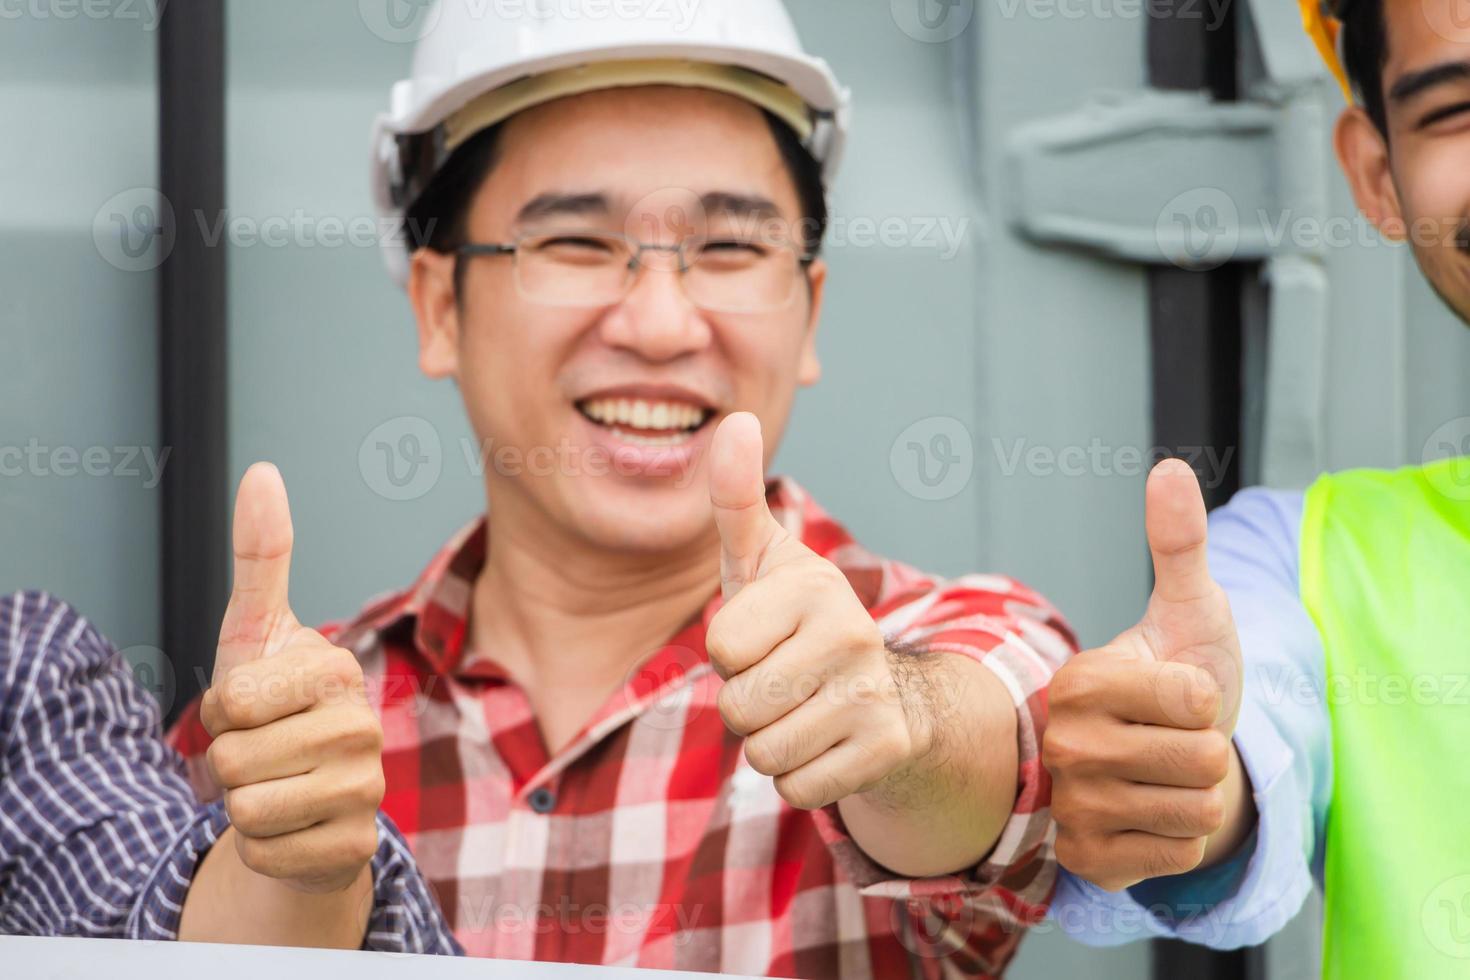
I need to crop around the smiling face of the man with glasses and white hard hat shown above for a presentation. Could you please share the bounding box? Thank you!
[410,87,825,552]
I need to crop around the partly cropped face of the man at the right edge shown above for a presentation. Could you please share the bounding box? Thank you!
[1336,0,1470,323]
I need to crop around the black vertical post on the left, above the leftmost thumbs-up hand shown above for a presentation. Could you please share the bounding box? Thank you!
[159,0,229,718]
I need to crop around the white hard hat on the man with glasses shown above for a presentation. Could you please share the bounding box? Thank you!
[372,0,851,285]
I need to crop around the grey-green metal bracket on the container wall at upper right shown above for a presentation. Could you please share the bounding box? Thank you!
[1005,44,1332,486]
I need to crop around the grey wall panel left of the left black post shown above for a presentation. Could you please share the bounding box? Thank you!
[0,11,163,667]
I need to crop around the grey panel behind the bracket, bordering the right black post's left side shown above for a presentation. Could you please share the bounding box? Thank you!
[970,3,1151,980]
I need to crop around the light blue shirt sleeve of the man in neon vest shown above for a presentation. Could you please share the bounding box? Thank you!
[1050,489,1332,949]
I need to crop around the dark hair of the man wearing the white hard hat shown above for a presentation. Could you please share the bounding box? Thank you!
[404,110,828,292]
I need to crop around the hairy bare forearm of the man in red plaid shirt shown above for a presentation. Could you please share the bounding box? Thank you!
[838,652,1017,877]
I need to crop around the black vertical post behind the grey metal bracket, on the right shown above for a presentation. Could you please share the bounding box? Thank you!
[1148,0,1264,980]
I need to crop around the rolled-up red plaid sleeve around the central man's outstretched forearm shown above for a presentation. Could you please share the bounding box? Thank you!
[814,576,1076,976]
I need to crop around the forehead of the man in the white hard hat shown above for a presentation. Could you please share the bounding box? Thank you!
[484,85,797,220]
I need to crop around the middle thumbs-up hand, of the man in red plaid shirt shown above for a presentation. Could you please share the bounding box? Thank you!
[706,413,929,810]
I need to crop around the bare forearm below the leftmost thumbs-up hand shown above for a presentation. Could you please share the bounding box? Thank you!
[179,827,373,949]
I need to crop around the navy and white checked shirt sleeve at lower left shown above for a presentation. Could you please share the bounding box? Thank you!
[0,592,457,952]
